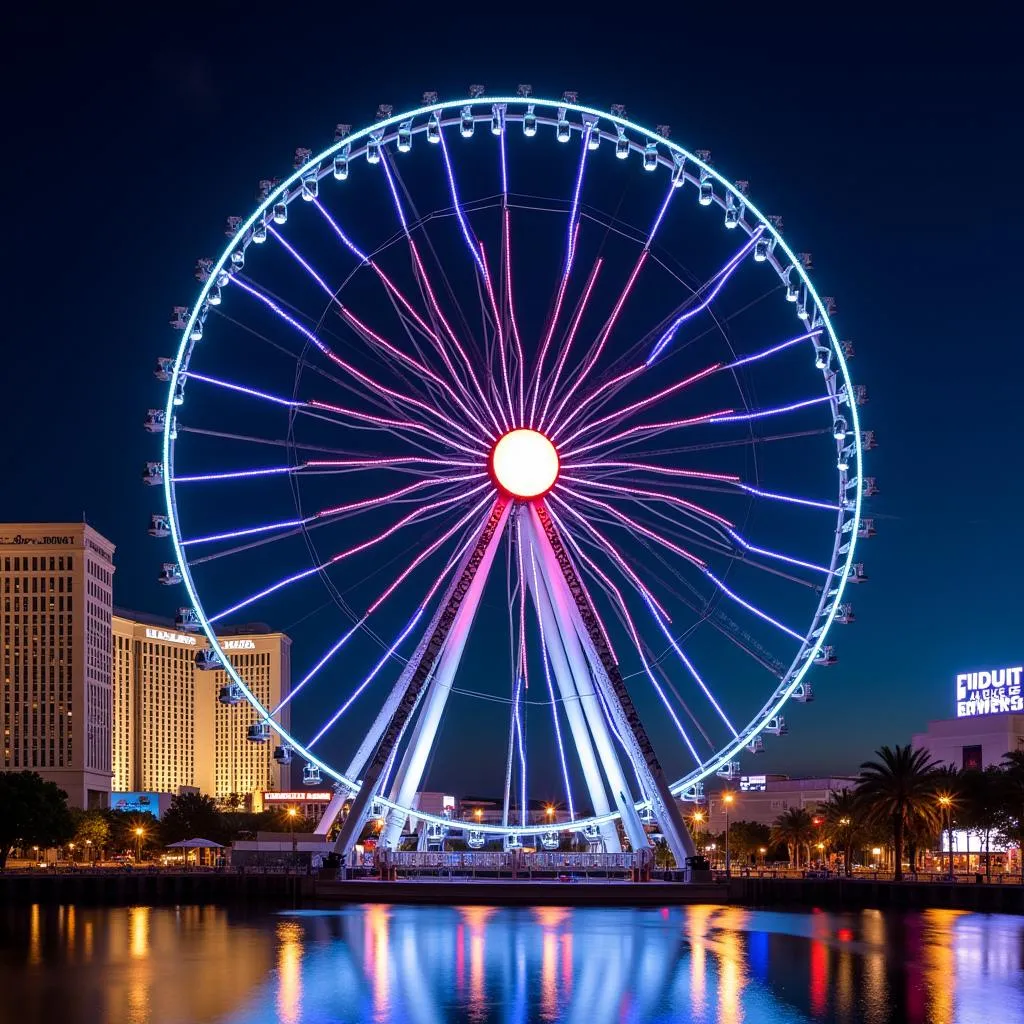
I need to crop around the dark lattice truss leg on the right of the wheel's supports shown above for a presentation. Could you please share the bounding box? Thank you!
[530,502,696,867]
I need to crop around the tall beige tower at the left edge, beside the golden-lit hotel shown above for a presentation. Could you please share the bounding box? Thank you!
[0,522,115,807]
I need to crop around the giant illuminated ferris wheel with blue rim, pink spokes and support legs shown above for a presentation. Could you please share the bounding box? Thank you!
[143,86,874,862]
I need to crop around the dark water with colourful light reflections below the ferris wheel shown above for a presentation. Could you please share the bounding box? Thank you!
[0,906,1024,1024]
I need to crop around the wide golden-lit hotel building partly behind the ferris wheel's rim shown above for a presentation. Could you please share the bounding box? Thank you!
[114,609,292,801]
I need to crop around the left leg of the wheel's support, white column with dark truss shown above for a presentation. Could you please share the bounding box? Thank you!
[335,498,510,856]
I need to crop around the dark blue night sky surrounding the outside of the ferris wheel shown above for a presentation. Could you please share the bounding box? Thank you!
[0,12,1024,788]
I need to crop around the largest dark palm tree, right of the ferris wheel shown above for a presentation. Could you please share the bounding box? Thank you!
[856,743,938,882]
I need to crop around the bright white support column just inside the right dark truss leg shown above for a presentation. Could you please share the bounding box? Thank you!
[529,507,650,851]
